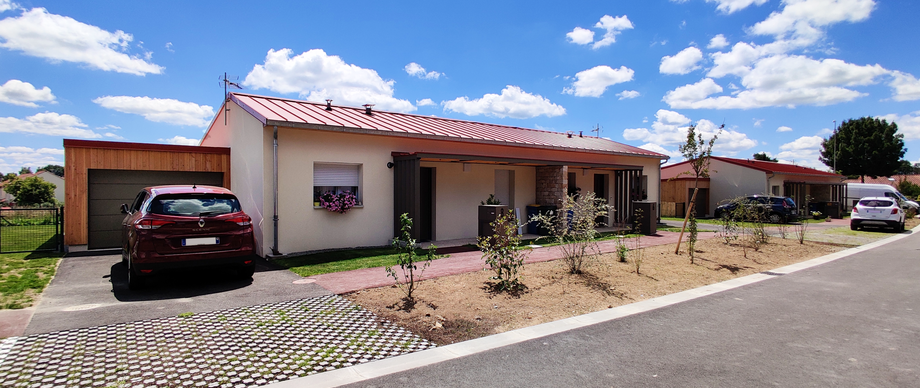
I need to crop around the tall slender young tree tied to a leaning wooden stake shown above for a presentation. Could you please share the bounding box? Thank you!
[674,124,725,264]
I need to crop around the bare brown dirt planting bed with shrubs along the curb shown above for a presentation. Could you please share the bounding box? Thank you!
[345,229,864,345]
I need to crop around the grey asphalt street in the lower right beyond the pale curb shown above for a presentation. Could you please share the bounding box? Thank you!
[338,233,920,387]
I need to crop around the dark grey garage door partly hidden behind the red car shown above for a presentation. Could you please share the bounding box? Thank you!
[87,170,224,249]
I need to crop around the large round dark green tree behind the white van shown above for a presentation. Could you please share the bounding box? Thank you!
[820,117,907,182]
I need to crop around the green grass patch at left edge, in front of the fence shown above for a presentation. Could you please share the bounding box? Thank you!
[0,253,61,309]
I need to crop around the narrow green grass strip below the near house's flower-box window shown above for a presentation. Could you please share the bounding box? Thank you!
[273,247,447,276]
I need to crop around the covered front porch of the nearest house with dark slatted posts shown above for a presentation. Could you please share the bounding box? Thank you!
[392,152,648,241]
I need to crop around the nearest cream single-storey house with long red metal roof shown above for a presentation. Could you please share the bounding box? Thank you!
[201,93,667,255]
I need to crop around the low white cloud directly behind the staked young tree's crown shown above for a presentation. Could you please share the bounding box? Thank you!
[623,109,758,156]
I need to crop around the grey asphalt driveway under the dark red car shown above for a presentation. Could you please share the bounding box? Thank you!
[25,255,331,335]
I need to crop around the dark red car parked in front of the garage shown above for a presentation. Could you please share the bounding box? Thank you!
[121,185,255,289]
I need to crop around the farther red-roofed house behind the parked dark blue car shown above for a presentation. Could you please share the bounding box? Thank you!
[661,156,846,216]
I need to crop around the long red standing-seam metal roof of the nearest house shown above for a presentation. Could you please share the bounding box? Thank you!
[230,93,667,159]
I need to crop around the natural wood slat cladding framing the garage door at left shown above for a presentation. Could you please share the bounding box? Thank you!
[64,141,230,245]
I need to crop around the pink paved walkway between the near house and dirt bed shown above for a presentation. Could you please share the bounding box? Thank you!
[307,232,716,294]
